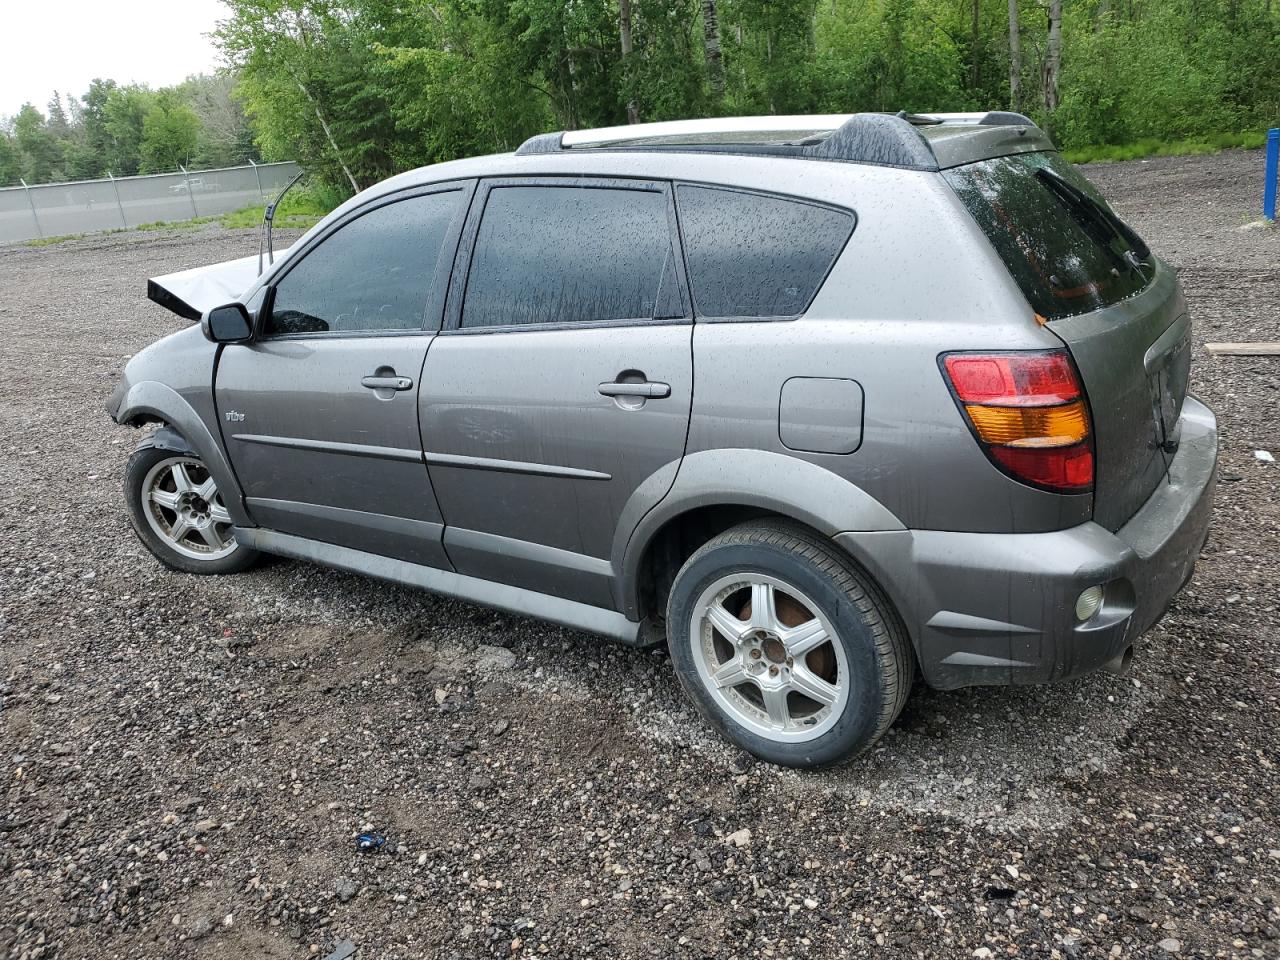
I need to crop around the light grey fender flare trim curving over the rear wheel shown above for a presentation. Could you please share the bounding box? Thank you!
[613,448,906,620]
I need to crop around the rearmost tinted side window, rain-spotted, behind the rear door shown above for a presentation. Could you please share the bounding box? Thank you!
[677,186,854,316]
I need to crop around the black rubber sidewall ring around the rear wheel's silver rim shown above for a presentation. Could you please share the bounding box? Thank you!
[667,543,886,767]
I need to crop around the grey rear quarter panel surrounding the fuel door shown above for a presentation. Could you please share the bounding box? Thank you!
[676,168,1092,532]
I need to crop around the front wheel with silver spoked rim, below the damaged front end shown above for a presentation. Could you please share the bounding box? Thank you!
[124,447,259,575]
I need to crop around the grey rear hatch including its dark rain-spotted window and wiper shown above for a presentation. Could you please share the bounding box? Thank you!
[943,152,1190,530]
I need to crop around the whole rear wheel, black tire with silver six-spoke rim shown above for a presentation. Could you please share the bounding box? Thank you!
[667,521,915,767]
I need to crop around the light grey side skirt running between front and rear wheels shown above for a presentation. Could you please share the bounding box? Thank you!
[234,526,648,646]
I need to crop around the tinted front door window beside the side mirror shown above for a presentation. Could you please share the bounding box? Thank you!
[266,191,461,335]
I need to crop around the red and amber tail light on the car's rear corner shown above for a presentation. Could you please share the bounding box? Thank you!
[940,349,1093,493]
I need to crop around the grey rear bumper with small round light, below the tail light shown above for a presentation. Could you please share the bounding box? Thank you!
[836,397,1217,689]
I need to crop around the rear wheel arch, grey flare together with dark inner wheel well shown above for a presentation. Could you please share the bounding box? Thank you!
[614,449,905,621]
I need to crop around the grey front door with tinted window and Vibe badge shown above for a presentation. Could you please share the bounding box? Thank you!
[215,182,474,568]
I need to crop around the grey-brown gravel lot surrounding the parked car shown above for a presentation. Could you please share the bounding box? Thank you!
[0,152,1280,957]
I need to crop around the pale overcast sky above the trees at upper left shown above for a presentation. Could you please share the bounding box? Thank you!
[0,0,228,116]
